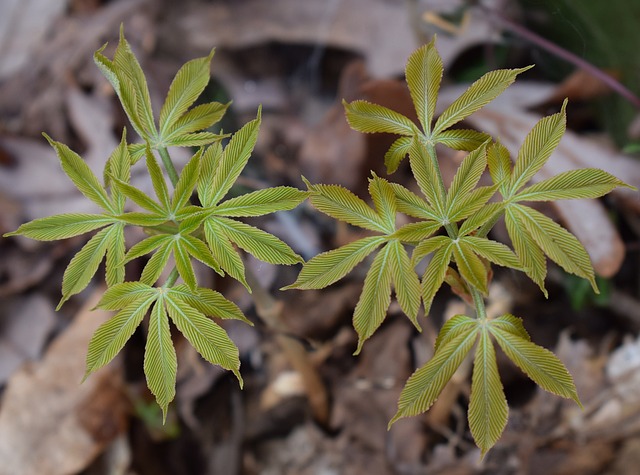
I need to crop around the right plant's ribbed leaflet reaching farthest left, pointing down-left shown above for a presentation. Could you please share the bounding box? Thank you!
[282,236,385,290]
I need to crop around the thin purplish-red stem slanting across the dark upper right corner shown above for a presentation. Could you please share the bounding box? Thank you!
[477,4,640,109]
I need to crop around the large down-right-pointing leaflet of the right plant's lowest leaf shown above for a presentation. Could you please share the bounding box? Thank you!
[488,322,582,407]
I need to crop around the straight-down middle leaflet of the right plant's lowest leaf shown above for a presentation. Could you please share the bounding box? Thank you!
[468,326,509,456]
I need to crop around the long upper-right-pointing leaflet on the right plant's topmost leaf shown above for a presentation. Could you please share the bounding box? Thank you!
[433,66,532,136]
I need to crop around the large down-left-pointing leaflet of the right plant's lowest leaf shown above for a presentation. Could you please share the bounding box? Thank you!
[389,326,478,427]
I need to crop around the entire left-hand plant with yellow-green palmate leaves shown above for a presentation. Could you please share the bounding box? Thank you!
[7,27,308,415]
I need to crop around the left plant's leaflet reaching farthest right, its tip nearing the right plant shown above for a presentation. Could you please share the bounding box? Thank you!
[212,186,309,217]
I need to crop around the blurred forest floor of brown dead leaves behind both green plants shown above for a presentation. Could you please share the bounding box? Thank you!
[0,0,640,475]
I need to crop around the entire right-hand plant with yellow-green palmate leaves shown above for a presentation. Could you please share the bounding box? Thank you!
[288,39,627,453]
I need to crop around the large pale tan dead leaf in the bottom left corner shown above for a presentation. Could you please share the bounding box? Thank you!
[0,289,128,475]
